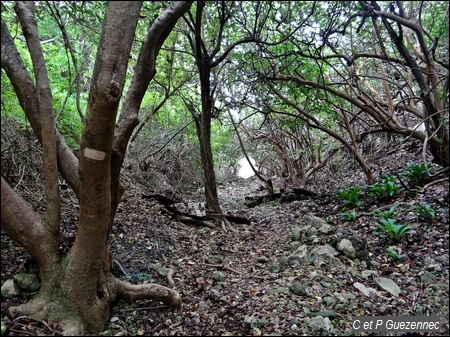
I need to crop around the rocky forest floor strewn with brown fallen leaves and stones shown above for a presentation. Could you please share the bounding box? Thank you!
[1,141,449,336]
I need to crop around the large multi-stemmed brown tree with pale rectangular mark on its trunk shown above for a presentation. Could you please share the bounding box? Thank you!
[1,1,192,335]
